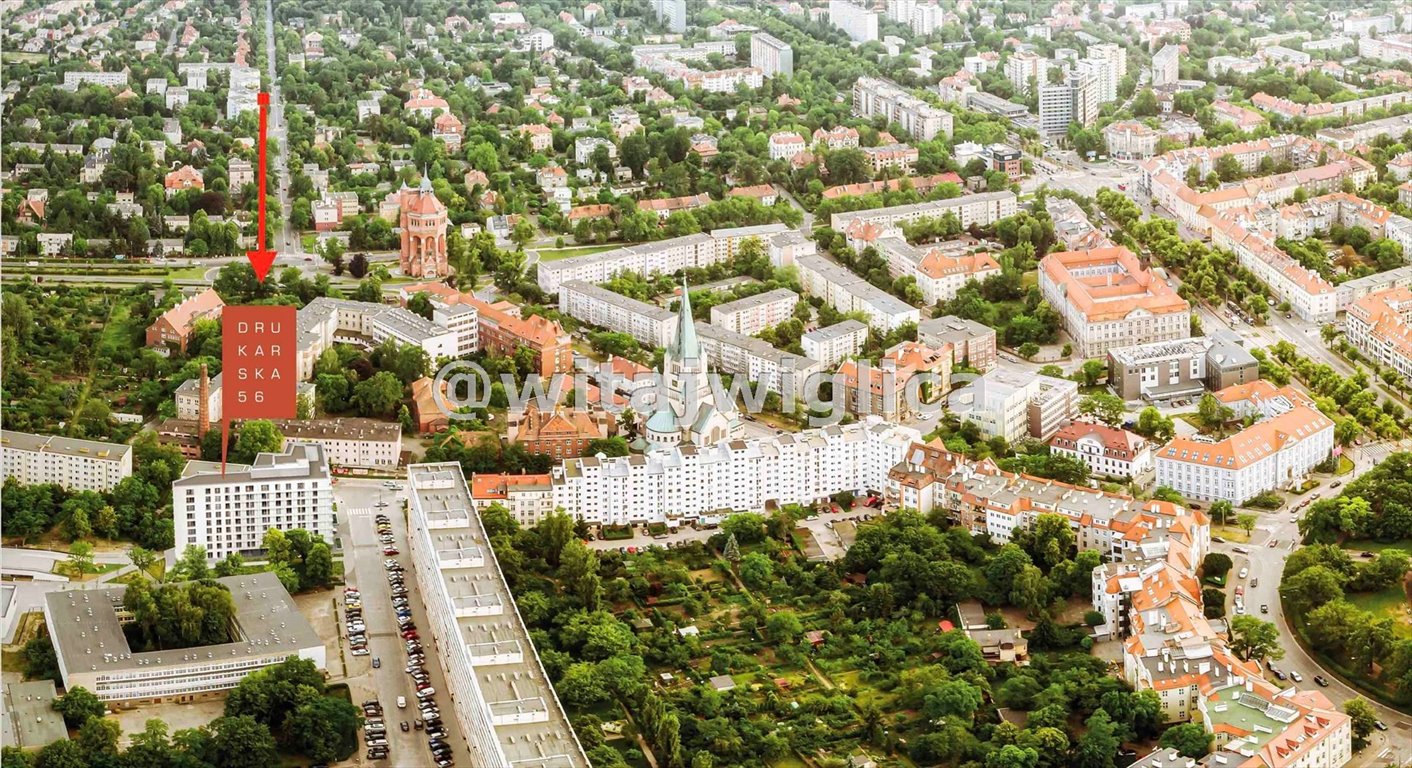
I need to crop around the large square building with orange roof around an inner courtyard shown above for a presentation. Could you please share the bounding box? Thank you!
[1039,246,1192,357]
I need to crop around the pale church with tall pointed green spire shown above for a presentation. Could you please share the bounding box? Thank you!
[638,281,744,452]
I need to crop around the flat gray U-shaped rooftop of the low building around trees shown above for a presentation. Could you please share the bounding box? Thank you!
[44,572,323,672]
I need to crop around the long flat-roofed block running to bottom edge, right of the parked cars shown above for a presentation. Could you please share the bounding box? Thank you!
[407,463,589,768]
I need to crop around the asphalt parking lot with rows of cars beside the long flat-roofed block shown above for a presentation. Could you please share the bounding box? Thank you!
[335,479,470,768]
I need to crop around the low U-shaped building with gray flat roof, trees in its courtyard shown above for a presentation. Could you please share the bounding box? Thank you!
[44,572,326,709]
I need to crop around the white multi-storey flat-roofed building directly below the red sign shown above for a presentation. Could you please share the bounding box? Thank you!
[172,445,337,562]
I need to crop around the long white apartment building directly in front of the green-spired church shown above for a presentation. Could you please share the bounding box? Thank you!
[552,416,919,528]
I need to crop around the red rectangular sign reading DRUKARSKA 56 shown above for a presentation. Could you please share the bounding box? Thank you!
[220,306,299,419]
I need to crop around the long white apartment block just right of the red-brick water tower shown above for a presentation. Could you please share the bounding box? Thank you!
[539,224,788,294]
